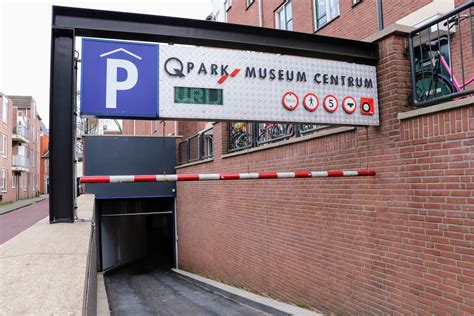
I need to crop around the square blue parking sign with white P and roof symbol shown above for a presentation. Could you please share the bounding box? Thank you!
[81,39,159,118]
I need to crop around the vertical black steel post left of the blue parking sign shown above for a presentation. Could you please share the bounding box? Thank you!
[49,28,76,223]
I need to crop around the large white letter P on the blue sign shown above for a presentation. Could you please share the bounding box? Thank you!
[105,58,138,109]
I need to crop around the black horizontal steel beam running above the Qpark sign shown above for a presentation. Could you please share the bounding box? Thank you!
[53,6,378,65]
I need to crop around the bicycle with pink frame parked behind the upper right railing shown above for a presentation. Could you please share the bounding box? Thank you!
[415,15,474,102]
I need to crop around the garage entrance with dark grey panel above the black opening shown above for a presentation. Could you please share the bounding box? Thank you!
[83,135,176,271]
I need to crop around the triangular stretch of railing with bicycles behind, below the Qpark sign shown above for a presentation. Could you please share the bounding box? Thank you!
[227,122,330,153]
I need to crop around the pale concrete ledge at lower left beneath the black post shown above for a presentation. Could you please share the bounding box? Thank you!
[0,195,95,315]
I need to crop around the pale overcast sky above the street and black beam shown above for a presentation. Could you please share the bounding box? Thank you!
[0,0,212,126]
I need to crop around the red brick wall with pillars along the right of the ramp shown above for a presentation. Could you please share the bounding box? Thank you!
[177,32,474,315]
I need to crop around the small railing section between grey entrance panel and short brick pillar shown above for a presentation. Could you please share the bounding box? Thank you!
[178,128,214,164]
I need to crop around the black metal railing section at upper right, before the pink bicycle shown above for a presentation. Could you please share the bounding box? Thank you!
[408,1,474,107]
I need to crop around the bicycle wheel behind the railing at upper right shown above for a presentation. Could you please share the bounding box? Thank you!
[415,71,456,102]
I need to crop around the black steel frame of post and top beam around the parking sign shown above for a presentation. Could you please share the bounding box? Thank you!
[49,6,378,223]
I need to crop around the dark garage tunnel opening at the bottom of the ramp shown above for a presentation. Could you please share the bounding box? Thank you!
[96,198,175,271]
